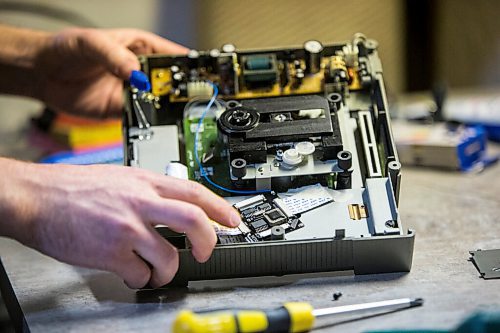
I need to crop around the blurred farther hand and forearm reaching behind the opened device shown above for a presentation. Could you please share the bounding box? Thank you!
[0,25,187,117]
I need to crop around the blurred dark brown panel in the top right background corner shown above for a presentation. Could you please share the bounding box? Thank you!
[431,0,500,88]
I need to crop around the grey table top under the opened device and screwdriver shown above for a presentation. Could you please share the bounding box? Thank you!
[0,165,500,332]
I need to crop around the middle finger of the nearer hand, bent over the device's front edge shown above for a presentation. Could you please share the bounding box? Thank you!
[142,199,217,262]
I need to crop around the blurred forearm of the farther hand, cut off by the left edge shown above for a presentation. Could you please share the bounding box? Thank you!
[0,25,50,98]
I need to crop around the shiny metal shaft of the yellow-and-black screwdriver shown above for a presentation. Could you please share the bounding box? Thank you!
[312,298,424,317]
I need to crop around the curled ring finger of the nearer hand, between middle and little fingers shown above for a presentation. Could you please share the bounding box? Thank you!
[134,226,179,288]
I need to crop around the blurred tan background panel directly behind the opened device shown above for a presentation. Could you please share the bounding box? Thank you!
[191,0,405,92]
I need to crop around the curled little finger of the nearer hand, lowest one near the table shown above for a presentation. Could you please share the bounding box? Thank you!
[112,252,151,289]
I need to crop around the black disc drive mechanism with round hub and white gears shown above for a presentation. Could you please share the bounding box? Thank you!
[217,95,343,191]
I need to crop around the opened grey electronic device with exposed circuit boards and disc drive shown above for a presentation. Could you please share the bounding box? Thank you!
[124,34,415,285]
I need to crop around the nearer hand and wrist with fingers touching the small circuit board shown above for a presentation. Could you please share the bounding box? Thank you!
[0,159,240,288]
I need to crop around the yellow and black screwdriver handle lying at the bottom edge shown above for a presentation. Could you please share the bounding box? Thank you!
[173,302,314,333]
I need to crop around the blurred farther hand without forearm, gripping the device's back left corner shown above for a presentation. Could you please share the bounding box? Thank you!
[35,28,187,118]
